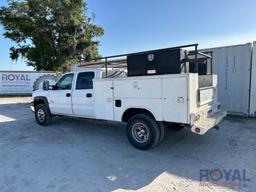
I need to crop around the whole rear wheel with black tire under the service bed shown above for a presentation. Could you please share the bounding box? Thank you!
[127,114,160,150]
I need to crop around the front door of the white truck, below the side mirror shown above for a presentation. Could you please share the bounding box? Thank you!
[48,73,74,115]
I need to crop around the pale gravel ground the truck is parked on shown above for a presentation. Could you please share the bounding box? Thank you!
[0,97,256,192]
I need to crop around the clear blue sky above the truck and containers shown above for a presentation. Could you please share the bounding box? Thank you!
[0,0,256,70]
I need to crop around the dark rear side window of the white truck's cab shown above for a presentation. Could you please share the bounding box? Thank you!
[76,72,94,89]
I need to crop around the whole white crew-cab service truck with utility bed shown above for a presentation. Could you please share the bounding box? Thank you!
[32,44,226,150]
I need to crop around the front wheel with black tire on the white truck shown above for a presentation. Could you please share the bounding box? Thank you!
[35,104,52,126]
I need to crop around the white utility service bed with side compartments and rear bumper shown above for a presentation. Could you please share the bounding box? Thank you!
[93,73,225,134]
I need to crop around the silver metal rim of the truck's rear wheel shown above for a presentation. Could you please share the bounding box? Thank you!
[132,123,149,143]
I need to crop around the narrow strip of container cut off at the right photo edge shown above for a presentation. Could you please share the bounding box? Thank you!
[250,41,256,117]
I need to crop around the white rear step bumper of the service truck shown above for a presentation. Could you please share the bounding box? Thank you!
[191,111,227,135]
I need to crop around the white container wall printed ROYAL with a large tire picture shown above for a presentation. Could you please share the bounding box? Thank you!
[0,71,56,95]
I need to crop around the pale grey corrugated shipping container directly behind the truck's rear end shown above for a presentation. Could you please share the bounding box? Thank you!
[202,43,252,116]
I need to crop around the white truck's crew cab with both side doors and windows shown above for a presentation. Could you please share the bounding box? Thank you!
[43,69,102,118]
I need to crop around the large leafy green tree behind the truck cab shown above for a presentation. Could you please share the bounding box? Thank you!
[0,0,104,71]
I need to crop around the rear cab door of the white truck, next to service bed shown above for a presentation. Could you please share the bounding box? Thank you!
[72,71,95,118]
